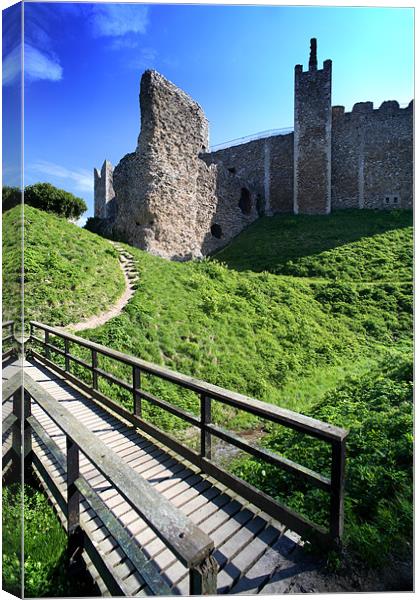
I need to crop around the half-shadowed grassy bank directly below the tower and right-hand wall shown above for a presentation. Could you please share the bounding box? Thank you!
[216,210,413,282]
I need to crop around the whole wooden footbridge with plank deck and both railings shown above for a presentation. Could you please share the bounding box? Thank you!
[3,322,347,596]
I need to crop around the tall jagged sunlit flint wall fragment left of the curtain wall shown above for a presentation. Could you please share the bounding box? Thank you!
[114,71,208,258]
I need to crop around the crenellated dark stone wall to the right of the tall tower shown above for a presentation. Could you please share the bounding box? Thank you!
[331,101,413,209]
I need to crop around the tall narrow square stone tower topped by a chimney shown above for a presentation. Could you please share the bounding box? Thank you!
[293,38,332,215]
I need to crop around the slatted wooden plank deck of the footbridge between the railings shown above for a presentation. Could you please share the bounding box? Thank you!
[3,361,318,596]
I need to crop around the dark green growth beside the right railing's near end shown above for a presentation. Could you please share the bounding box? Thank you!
[232,353,413,566]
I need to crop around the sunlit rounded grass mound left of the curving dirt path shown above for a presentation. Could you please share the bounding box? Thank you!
[3,206,124,325]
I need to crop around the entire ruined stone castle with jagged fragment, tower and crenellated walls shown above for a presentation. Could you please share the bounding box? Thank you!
[94,39,413,260]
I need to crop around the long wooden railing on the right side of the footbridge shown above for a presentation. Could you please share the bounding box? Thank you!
[29,321,348,544]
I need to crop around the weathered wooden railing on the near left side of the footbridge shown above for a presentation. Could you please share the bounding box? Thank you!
[3,373,217,596]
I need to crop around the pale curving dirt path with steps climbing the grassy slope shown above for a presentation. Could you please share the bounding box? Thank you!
[64,242,138,331]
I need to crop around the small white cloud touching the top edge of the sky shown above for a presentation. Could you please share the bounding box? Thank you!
[92,4,149,37]
